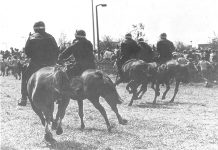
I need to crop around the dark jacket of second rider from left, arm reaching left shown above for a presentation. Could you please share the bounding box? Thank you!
[59,38,95,71]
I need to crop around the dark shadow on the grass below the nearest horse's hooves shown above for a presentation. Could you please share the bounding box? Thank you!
[46,140,98,150]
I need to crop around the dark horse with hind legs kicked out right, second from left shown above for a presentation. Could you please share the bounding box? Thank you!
[71,69,127,132]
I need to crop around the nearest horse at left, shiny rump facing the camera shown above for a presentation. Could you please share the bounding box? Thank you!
[27,66,75,142]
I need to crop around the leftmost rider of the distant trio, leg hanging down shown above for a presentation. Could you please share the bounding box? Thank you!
[116,33,139,85]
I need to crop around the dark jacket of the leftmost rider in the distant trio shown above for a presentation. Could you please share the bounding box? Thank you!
[121,39,140,62]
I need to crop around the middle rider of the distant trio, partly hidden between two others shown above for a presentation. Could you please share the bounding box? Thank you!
[138,38,153,62]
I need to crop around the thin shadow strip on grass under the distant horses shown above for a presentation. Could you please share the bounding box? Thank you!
[136,102,206,109]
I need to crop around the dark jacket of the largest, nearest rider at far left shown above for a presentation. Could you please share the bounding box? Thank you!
[25,32,59,65]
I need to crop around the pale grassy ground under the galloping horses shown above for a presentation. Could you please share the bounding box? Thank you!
[0,76,218,150]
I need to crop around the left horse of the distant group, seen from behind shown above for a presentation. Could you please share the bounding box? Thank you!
[115,59,156,106]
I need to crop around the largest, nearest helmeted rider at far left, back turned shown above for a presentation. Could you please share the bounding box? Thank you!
[18,21,59,106]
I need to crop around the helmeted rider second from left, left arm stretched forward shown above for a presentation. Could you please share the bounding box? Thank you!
[58,30,95,78]
